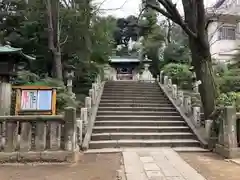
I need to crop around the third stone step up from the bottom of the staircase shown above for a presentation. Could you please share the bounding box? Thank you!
[93,126,190,133]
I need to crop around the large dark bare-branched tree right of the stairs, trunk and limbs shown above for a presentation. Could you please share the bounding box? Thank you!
[146,0,218,118]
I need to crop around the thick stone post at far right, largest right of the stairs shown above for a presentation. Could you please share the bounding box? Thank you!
[216,106,239,158]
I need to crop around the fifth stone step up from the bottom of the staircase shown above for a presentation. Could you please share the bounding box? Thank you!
[96,115,182,121]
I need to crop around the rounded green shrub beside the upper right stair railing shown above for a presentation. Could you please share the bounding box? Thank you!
[163,63,192,89]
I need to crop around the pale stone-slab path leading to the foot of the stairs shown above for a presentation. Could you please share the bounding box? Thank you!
[123,148,206,180]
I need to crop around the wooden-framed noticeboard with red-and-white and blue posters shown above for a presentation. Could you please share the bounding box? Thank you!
[14,86,56,115]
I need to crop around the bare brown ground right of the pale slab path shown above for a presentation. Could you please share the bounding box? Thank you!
[179,152,240,180]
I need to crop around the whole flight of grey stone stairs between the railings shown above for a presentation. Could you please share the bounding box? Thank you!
[89,81,201,149]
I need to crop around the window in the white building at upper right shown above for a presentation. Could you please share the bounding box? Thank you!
[218,26,236,40]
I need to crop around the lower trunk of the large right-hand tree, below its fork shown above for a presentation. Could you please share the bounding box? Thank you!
[190,38,217,119]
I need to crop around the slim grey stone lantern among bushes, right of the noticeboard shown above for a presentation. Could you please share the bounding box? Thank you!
[64,65,76,99]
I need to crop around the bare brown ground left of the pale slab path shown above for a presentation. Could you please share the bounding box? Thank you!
[0,154,122,180]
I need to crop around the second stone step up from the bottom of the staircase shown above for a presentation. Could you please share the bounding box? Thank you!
[91,132,195,141]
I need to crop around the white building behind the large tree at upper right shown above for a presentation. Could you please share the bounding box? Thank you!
[207,0,240,63]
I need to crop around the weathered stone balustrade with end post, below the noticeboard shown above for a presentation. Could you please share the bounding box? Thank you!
[0,107,79,163]
